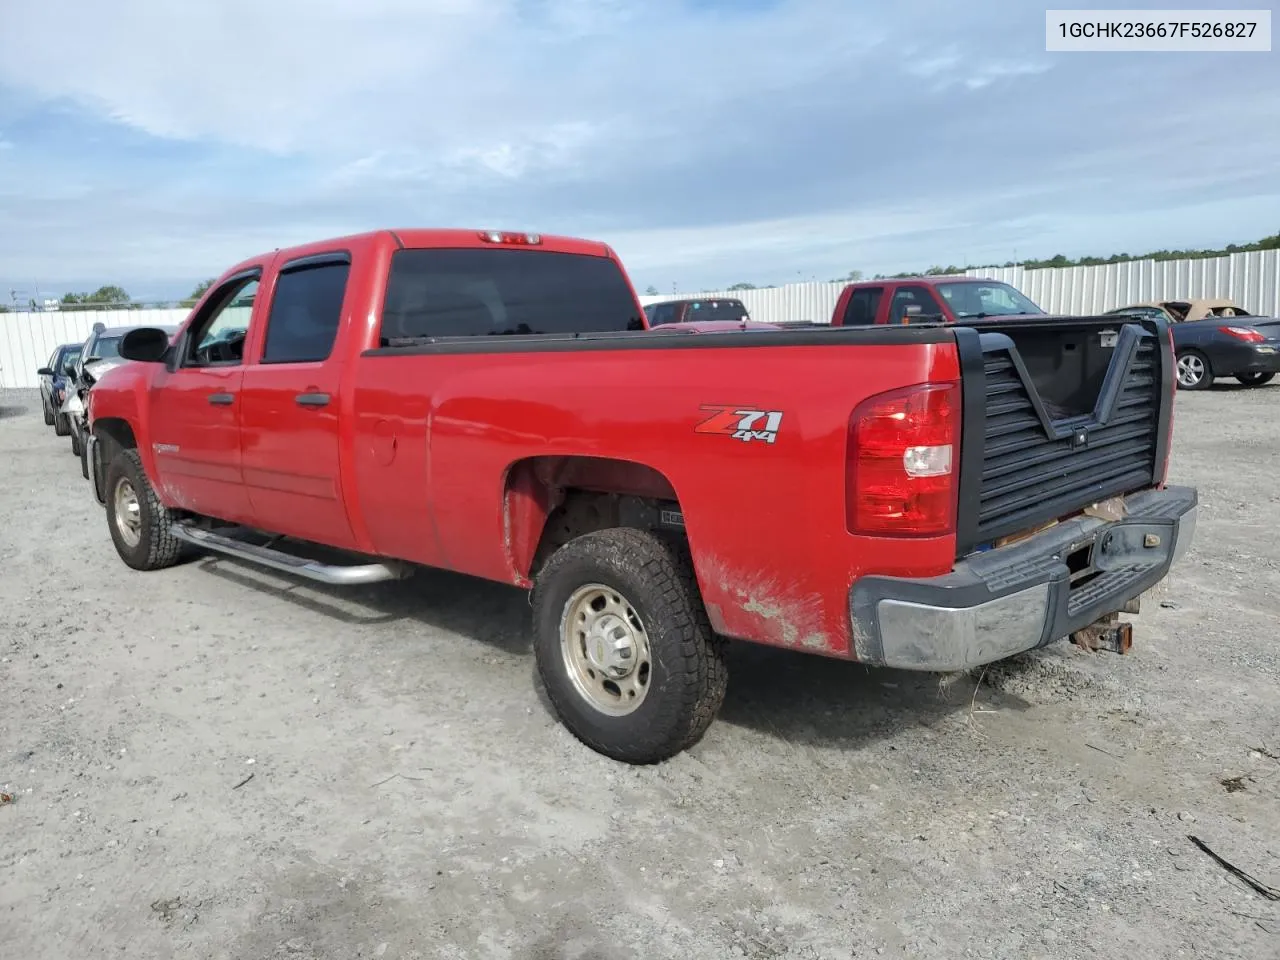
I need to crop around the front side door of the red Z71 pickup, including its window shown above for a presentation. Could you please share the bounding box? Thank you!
[147,268,262,524]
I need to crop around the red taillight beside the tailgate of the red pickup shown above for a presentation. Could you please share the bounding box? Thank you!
[845,383,960,536]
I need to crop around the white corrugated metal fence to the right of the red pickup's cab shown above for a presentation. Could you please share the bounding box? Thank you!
[640,250,1280,324]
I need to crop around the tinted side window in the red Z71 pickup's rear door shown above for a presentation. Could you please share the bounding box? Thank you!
[262,262,351,364]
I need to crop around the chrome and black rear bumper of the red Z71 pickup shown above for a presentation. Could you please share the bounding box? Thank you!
[849,486,1198,672]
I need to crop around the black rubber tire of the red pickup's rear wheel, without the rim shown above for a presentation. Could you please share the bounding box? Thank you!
[532,527,728,764]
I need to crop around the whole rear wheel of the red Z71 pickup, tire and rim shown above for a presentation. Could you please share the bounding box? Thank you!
[532,527,727,763]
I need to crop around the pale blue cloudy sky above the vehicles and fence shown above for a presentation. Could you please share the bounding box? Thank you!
[0,0,1280,302]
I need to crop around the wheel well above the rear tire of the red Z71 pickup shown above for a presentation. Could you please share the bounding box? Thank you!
[503,457,685,579]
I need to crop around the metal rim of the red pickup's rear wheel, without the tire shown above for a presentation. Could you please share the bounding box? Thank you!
[561,584,653,717]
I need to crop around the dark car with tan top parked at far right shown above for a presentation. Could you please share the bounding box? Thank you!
[1108,301,1280,390]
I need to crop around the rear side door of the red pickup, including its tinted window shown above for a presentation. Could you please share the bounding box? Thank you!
[241,251,356,548]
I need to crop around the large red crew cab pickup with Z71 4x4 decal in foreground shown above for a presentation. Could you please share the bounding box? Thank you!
[87,230,1197,763]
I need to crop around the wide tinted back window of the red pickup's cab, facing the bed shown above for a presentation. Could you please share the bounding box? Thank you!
[381,250,643,346]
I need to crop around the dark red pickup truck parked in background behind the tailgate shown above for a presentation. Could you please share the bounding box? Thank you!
[831,276,1044,326]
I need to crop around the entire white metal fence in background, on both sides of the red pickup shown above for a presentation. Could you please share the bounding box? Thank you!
[0,250,1280,387]
